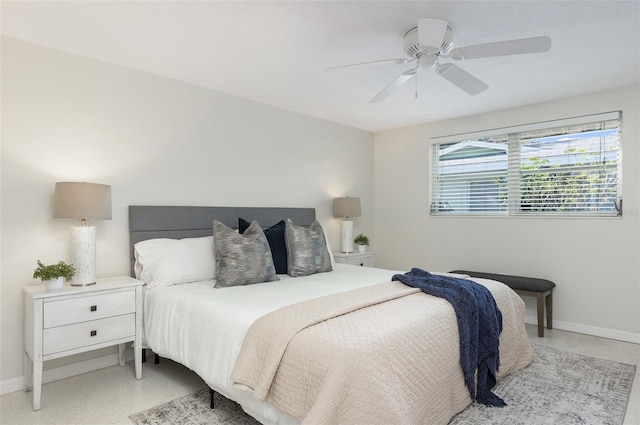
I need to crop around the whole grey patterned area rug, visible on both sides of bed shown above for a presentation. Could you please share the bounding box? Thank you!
[129,345,636,425]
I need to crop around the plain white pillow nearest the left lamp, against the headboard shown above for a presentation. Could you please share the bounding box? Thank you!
[134,236,216,286]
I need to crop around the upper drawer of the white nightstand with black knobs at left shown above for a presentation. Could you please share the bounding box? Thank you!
[44,290,136,329]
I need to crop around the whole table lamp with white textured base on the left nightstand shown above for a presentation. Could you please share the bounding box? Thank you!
[53,182,111,286]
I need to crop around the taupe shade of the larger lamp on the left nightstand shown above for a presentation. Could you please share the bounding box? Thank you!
[53,182,111,220]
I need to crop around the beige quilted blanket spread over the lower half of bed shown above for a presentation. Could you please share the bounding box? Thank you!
[231,279,532,425]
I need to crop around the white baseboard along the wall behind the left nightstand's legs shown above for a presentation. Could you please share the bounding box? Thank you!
[0,350,153,395]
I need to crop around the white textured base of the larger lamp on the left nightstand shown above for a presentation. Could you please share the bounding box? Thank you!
[71,226,96,286]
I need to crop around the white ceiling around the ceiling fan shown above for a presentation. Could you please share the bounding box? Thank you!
[1,1,640,131]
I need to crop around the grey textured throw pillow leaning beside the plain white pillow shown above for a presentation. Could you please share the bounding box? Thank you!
[213,220,280,288]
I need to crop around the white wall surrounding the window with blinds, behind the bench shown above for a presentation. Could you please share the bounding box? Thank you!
[374,87,640,343]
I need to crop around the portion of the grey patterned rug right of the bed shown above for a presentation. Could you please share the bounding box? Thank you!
[449,344,636,425]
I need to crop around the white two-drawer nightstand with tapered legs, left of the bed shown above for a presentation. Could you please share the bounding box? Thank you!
[24,276,144,410]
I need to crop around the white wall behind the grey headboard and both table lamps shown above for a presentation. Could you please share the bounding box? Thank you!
[0,37,373,391]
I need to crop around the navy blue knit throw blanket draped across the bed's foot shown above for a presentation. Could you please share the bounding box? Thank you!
[391,268,506,407]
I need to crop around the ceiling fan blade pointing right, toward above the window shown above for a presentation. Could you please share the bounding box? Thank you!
[449,36,551,60]
